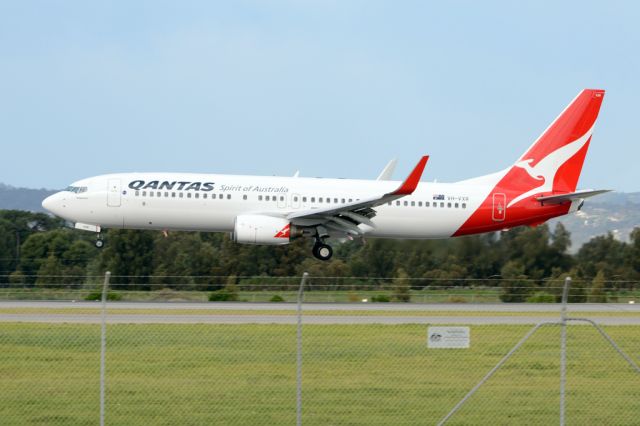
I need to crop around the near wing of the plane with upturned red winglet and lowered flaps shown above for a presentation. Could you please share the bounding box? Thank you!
[287,156,429,235]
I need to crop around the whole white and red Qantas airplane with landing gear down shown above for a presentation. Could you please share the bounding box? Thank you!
[42,89,607,260]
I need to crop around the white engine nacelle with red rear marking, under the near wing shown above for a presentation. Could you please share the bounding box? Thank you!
[232,214,299,245]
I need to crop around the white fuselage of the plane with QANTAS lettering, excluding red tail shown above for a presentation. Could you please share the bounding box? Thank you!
[43,172,504,238]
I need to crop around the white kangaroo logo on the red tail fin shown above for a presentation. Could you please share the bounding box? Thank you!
[507,127,593,208]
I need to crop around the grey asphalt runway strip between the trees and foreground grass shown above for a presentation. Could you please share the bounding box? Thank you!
[0,301,640,325]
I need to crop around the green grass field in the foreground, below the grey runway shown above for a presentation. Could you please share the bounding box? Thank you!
[0,323,640,425]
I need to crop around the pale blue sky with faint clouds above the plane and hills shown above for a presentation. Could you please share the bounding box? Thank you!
[0,0,640,192]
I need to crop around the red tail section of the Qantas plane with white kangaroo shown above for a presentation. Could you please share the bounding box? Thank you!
[454,89,604,236]
